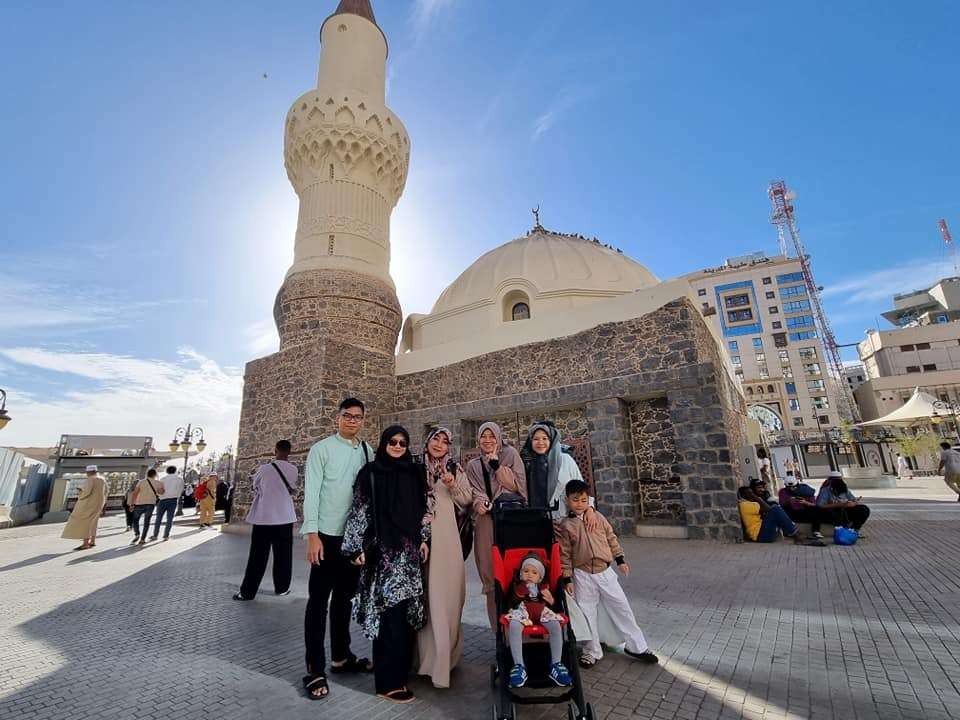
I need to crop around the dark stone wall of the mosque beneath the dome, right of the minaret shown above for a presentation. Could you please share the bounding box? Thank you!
[385,300,741,541]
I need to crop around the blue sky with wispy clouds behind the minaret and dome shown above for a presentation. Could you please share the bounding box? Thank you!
[0,0,960,447]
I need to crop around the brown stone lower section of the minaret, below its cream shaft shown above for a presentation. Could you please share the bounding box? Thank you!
[234,270,400,518]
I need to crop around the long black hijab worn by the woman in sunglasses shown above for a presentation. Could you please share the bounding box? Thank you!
[364,425,427,549]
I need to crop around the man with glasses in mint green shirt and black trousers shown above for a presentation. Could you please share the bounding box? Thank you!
[300,398,373,699]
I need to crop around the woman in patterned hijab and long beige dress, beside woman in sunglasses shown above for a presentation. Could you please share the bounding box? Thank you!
[415,427,472,688]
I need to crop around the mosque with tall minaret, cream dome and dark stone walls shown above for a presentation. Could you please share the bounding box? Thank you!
[236,0,747,541]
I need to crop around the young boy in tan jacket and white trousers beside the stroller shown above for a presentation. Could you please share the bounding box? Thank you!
[557,480,659,667]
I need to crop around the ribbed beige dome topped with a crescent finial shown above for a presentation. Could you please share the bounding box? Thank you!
[430,227,660,315]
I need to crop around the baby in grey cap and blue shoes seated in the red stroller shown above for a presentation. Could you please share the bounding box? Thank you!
[505,553,571,688]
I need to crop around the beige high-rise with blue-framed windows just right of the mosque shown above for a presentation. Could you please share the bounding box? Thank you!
[685,252,840,439]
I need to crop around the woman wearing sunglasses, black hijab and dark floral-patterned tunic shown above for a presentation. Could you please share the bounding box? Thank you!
[342,425,430,703]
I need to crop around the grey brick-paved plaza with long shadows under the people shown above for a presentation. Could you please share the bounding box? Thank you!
[0,485,960,720]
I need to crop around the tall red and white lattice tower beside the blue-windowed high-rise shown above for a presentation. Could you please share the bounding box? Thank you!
[767,180,860,423]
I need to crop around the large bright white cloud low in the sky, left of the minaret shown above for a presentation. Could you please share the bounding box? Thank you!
[0,347,243,448]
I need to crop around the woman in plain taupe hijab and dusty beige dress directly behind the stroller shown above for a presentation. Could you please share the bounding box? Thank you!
[467,422,527,632]
